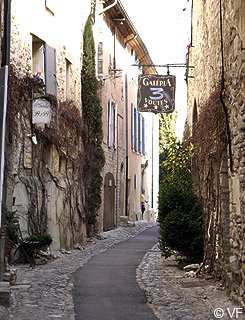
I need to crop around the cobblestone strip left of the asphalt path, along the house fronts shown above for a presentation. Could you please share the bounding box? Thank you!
[0,221,155,320]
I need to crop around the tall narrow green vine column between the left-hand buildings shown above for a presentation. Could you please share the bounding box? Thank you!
[82,16,105,224]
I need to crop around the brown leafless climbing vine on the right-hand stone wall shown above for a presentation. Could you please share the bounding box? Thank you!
[189,81,228,271]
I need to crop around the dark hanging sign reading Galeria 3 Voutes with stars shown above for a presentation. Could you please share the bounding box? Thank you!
[137,74,176,113]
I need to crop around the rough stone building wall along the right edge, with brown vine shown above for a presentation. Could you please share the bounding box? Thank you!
[187,0,245,307]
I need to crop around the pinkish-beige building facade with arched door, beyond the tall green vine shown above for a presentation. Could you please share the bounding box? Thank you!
[93,1,158,230]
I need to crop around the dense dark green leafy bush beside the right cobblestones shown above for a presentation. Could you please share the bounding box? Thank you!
[158,137,203,261]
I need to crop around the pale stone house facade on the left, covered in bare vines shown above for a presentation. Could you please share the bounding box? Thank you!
[1,0,91,249]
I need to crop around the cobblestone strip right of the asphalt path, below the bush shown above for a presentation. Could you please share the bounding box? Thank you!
[136,245,242,320]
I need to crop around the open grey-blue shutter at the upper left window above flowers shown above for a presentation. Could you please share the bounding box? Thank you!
[44,43,57,96]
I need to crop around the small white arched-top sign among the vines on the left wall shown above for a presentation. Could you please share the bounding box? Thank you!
[32,98,51,124]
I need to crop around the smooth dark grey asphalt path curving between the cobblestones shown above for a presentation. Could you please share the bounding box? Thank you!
[73,227,158,320]
